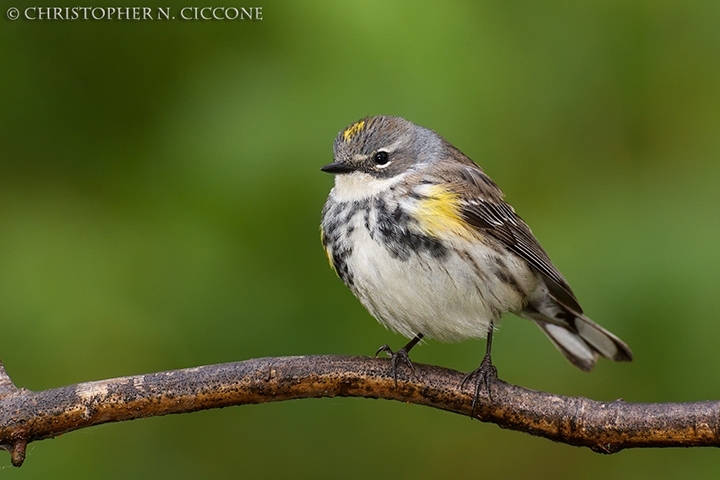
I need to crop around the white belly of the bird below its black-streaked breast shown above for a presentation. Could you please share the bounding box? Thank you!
[338,202,537,342]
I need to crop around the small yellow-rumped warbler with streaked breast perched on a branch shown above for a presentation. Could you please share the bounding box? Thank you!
[321,116,632,394]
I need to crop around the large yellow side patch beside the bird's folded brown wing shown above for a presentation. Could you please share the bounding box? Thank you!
[415,185,472,242]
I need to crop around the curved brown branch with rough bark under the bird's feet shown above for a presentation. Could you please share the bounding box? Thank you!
[0,355,720,466]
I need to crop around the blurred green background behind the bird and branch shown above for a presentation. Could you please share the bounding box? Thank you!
[0,0,720,480]
